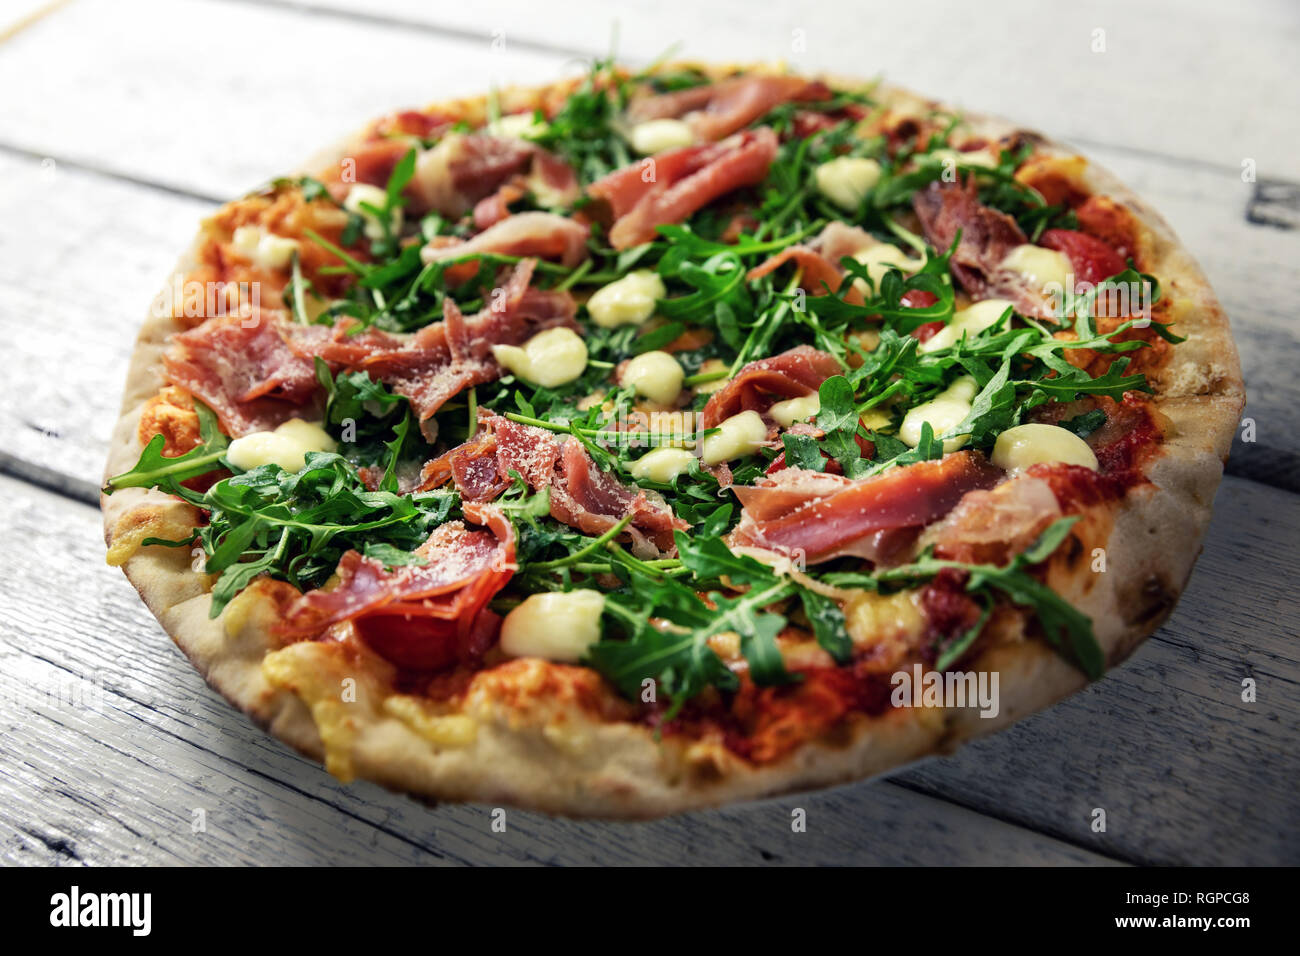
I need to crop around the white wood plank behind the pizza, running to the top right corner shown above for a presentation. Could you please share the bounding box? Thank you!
[295,0,1300,179]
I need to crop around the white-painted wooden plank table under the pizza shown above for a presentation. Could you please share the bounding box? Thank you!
[0,0,1300,864]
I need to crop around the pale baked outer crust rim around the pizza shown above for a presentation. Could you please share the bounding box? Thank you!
[101,64,1244,818]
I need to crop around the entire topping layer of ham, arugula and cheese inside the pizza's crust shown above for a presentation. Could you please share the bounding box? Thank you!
[114,64,1178,743]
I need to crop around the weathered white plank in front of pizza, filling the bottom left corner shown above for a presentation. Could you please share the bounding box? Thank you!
[0,477,1109,864]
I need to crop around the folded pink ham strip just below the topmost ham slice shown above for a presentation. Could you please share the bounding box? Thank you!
[588,126,777,250]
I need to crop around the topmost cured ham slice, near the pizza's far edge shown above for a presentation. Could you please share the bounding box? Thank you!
[628,77,831,140]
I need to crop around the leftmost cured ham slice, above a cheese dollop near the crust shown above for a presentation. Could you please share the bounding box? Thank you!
[163,311,316,437]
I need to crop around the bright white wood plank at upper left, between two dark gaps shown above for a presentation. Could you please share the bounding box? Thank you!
[0,0,566,196]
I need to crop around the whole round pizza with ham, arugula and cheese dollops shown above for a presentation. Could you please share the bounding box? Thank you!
[103,61,1244,818]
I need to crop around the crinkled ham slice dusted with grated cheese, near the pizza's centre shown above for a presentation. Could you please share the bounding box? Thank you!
[420,412,688,557]
